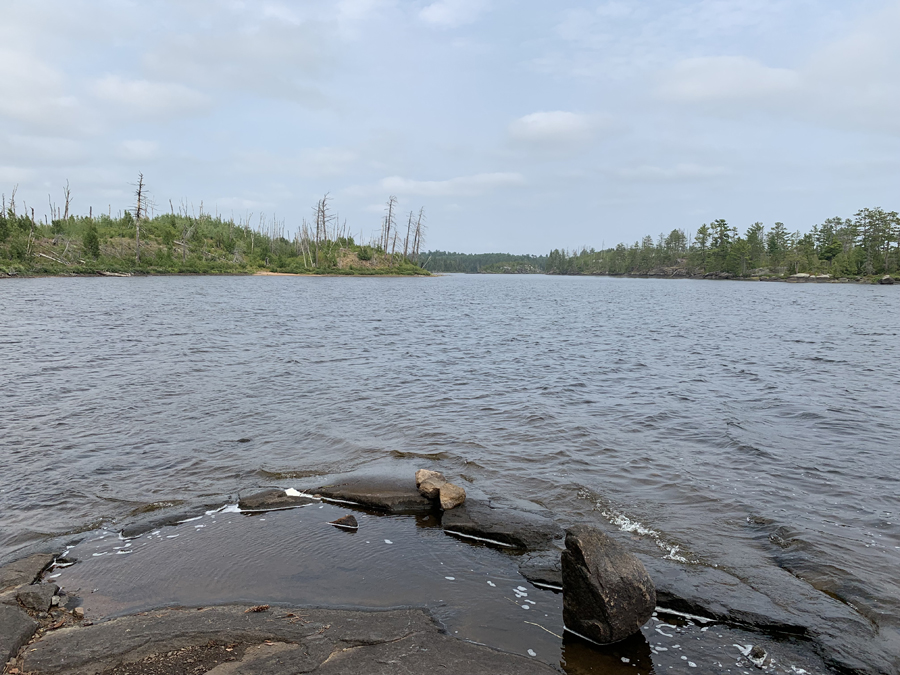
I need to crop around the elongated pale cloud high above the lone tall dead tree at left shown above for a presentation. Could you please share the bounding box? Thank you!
[93,75,210,117]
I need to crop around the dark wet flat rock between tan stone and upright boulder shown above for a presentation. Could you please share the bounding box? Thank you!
[441,500,565,550]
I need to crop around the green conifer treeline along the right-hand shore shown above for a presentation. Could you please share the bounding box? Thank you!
[546,208,900,277]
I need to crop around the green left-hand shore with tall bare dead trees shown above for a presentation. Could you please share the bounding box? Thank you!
[0,182,430,277]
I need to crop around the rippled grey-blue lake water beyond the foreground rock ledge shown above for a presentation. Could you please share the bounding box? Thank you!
[0,275,900,668]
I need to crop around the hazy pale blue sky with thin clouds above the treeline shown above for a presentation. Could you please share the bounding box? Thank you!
[0,0,900,254]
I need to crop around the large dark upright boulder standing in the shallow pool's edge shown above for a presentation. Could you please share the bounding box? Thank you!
[562,525,656,644]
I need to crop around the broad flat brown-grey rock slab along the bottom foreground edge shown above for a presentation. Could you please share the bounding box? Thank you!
[21,606,558,675]
